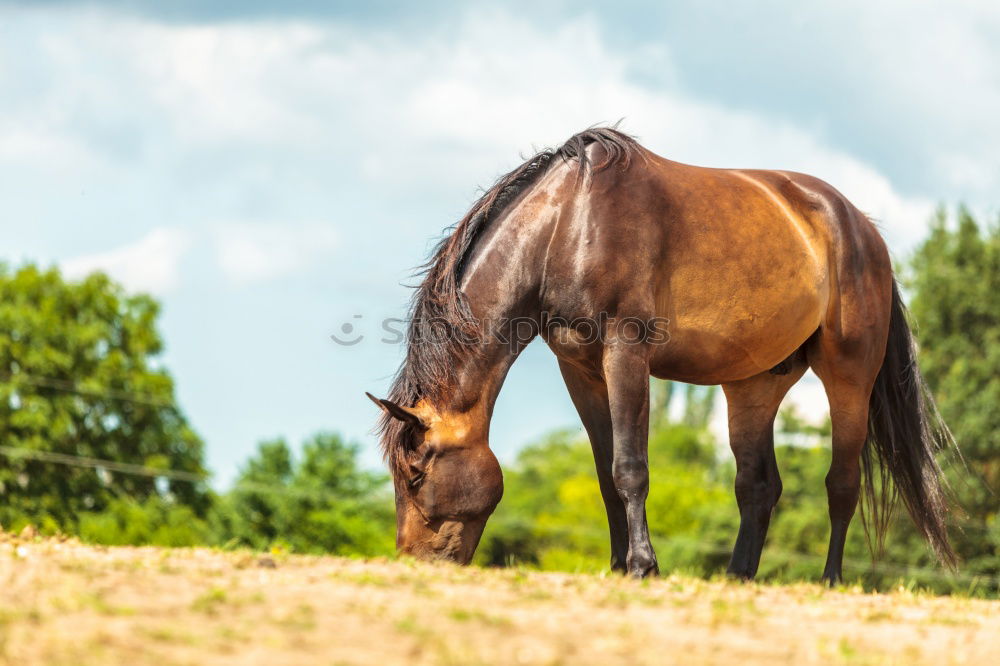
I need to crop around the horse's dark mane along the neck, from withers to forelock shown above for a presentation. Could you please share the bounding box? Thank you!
[379,127,639,470]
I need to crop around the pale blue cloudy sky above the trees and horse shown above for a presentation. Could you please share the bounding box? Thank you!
[0,0,1000,487]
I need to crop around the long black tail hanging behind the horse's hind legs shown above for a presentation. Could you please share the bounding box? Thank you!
[862,280,957,567]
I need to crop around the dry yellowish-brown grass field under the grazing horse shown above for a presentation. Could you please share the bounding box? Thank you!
[0,535,1000,666]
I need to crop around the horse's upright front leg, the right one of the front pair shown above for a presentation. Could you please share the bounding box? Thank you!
[604,344,659,578]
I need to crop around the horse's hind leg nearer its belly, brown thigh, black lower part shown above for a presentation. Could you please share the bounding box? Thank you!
[722,353,806,579]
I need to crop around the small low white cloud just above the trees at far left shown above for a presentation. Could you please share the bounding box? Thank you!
[61,227,191,294]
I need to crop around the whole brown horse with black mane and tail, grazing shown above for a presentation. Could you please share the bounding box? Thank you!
[369,128,955,582]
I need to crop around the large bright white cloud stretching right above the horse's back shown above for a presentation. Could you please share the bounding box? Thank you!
[384,16,933,247]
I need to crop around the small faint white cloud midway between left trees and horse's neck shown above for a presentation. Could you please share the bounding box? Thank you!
[215,222,337,285]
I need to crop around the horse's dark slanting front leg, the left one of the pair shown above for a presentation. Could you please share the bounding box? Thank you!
[559,360,628,571]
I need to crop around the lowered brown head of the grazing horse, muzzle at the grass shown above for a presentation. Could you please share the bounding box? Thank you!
[368,394,503,564]
